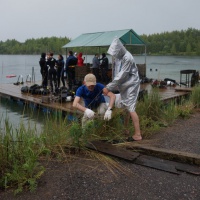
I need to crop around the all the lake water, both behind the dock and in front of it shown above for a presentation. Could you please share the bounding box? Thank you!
[0,55,200,130]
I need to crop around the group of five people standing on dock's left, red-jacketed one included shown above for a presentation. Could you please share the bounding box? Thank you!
[39,51,84,92]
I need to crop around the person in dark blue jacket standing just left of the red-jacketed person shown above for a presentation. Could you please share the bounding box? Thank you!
[66,51,78,89]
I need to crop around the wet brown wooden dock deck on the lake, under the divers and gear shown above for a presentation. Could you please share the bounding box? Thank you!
[0,83,191,113]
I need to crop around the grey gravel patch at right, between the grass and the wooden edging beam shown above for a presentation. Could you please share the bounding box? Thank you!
[144,112,200,154]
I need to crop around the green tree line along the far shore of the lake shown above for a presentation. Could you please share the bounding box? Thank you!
[0,28,200,56]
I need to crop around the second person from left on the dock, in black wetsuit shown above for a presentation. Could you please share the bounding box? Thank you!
[47,53,57,92]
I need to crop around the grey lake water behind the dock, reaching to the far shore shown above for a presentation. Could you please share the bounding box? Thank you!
[0,55,200,83]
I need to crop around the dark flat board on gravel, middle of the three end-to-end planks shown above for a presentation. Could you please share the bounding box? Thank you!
[134,155,180,174]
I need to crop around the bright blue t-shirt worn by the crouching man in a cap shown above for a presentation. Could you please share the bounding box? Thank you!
[76,83,105,109]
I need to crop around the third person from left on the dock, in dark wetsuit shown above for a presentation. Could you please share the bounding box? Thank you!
[57,54,65,88]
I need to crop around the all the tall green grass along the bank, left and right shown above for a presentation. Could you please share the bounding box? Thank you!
[0,87,200,194]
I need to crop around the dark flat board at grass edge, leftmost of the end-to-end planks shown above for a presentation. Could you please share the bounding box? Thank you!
[86,141,140,161]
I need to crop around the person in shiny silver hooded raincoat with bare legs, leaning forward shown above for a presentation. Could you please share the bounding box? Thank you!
[106,38,142,141]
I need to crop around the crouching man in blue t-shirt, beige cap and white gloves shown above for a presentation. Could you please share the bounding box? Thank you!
[73,74,115,127]
